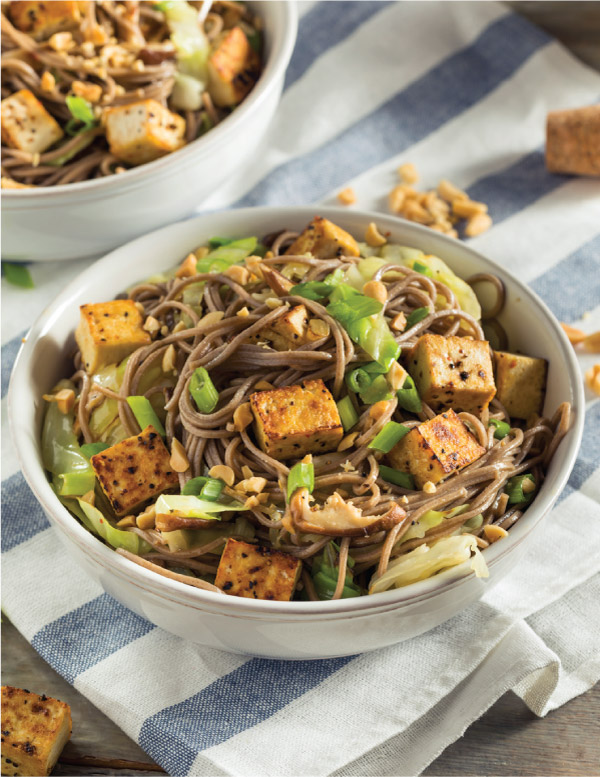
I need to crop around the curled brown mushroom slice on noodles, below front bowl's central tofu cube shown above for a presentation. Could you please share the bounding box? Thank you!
[283,488,406,537]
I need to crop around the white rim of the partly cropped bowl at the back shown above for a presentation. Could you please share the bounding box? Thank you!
[2,0,298,200]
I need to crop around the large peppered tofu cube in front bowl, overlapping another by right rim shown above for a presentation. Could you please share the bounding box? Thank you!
[407,334,496,415]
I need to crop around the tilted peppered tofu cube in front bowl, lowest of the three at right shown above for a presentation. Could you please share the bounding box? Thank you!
[387,410,485,488]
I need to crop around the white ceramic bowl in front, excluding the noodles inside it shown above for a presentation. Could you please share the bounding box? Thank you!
[8,208,584,659]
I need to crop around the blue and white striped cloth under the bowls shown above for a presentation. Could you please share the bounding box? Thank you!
[2,2,600,777]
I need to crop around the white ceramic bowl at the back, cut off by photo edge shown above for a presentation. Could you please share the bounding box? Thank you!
[2,0,298,261]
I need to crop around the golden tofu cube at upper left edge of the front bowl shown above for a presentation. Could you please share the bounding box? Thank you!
[75,299,151,374]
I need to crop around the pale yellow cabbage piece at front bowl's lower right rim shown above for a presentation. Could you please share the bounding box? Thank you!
[369,534,489,594]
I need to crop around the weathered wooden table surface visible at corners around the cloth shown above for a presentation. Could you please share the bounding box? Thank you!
[2,0,600,777]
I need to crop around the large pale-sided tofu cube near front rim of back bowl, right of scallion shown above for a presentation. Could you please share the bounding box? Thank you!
[102,100,185,165]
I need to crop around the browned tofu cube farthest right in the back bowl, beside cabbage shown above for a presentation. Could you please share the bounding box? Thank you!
[208,27,260,107]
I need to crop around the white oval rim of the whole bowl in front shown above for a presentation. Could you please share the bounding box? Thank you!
[8,205,585,619]
